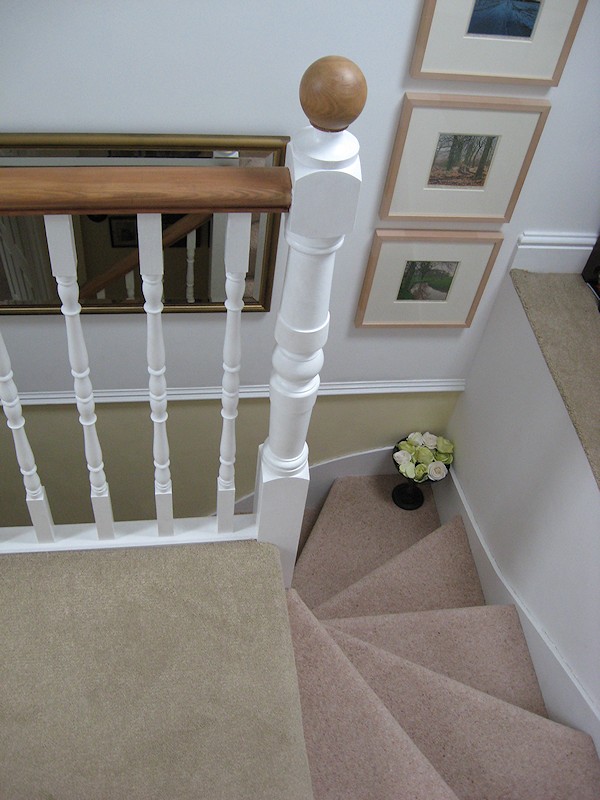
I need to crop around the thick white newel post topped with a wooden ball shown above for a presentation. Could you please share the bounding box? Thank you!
[255,56,367,586]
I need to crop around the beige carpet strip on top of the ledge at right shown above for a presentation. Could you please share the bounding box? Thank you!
[511,270,600,487]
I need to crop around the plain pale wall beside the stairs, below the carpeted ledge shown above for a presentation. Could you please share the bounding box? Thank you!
[448,277,600,746]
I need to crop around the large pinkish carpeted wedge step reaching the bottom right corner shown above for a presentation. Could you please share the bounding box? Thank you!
[329,628,600,800]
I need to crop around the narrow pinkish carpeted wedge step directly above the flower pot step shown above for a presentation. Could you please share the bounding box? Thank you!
[312,517,485,619]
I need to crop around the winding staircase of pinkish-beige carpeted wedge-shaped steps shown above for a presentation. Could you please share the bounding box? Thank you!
[288,476,600,800]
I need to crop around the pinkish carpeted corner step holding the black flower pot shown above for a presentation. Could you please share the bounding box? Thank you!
[292,475,440,608]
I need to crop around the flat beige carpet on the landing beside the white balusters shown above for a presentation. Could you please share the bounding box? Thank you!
[0,542,312,800]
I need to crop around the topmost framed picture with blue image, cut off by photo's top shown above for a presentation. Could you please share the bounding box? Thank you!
[410,0,587,86]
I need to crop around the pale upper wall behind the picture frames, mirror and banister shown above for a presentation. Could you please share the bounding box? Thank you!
[0,0,600,392]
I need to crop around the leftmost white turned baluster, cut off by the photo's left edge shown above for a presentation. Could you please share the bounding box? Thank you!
[0,333,54,542]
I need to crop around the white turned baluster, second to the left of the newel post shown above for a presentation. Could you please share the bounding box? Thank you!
[137,214,173,536]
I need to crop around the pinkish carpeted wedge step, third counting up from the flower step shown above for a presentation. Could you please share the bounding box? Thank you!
[324,606,547,716]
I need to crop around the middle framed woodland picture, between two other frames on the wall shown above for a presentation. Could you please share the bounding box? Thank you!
[380,92,550,224]
